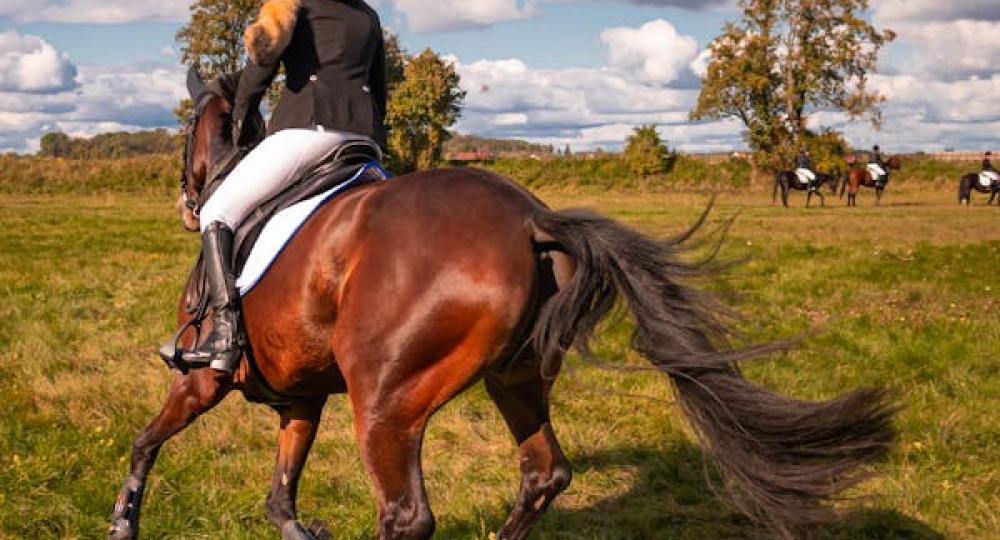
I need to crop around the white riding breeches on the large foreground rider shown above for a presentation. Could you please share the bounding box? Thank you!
[201,129,369,232]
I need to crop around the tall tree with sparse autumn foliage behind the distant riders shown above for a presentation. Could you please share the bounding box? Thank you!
[691,0,895,169]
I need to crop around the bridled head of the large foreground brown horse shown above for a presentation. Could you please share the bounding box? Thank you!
[177,68,250,231]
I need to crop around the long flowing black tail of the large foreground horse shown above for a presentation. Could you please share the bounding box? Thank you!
[532,206,896,538]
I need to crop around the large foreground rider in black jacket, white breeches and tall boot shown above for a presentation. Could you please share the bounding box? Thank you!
[170,0,387,373]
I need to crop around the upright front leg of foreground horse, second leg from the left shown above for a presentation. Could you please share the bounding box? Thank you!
[267,397,326,540]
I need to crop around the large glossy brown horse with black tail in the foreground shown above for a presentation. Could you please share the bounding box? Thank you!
[111,71,894,540]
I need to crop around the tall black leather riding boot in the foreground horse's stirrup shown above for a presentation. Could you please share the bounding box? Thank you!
[181,222,245,373]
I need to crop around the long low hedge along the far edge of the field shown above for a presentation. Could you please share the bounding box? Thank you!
[0,154,979,195]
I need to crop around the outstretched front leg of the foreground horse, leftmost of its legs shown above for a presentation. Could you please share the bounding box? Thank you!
[108,369,232,540]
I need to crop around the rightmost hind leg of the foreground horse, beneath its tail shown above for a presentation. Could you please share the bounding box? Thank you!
[486,354,572,540]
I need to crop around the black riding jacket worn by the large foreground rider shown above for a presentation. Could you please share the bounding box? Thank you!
[233,0,388,149]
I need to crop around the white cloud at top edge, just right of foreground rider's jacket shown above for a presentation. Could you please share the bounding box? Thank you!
[391,0,538,32]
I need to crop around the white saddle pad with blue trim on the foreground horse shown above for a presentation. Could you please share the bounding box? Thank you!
[236,161,392,296]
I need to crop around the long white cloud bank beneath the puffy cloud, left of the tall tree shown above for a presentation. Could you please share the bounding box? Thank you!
[457,55,742,150]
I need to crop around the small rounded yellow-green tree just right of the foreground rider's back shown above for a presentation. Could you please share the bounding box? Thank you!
[386,49,465,172]
